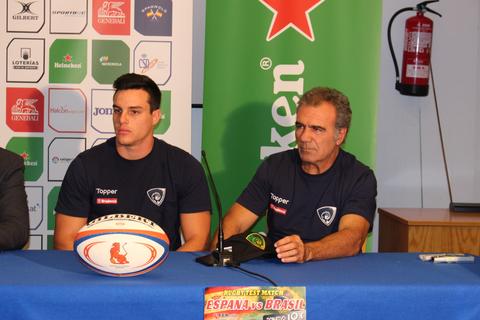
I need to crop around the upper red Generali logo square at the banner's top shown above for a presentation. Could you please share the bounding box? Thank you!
[93,0,130,35]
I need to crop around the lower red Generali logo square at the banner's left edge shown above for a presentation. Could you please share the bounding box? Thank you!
[6,88,44,132]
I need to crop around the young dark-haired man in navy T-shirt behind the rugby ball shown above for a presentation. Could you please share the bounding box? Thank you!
[54,73,210,251]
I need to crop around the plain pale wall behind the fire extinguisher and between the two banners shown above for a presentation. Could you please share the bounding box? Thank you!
[192,0,480,250]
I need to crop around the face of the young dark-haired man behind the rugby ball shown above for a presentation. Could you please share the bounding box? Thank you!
[113,89,160,147]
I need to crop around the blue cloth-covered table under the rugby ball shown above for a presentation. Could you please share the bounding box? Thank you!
[0,251,480,319]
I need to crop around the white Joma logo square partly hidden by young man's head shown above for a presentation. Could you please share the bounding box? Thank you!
[90,89,113,134]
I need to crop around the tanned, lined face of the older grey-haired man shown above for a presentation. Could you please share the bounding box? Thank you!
[295,102,347,174]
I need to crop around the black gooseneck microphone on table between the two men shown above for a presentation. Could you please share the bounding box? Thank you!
[195,150,233,267]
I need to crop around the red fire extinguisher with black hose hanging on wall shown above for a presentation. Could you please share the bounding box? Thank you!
[388,0,442,96]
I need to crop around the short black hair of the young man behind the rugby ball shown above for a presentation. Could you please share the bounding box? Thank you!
[113,73,162,112]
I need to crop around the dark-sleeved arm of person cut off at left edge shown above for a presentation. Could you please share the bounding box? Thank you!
[0,148,30,250]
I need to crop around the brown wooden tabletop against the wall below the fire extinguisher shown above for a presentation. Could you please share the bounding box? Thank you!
[378,208,480,226]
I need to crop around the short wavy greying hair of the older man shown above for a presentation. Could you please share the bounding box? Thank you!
[298,87,352,129]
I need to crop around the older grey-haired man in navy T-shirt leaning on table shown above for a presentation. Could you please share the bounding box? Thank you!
[211,88,377,263]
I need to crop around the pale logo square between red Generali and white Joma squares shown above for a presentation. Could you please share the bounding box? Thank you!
[48,88,87,133]
